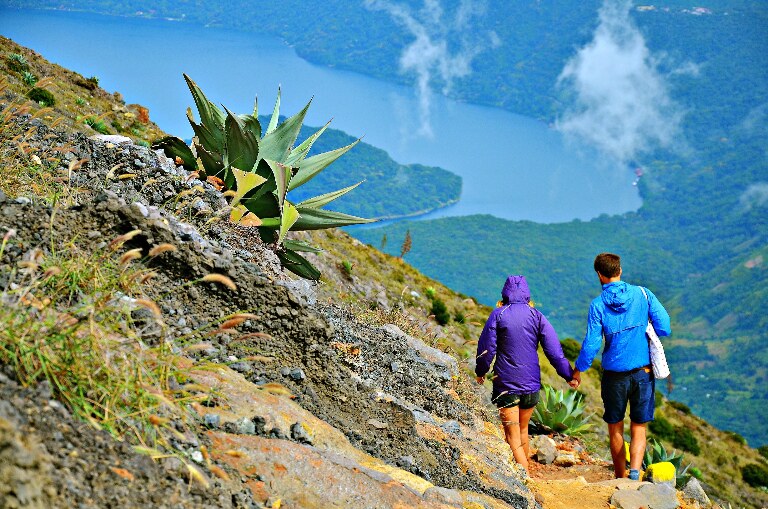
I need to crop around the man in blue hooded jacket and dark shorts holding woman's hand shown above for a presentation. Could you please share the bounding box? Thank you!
[569,253,671,480]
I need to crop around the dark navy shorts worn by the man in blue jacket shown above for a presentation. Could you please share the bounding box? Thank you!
[600,368,656,424]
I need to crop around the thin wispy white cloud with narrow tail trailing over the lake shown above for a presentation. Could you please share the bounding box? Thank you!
[364,0,500,137]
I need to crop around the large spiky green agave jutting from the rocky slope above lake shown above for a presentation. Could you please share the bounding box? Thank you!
[153,74,374,280]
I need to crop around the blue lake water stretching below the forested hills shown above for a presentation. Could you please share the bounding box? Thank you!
[0,7,640,222]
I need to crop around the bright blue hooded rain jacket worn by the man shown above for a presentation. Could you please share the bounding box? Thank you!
[576,281,672,371]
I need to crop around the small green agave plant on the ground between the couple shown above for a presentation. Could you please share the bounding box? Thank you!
[531,385,592,435]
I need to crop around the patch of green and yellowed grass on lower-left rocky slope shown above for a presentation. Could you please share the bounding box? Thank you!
[0,230,206,448]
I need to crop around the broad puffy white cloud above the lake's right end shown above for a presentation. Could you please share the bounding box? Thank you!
[557,0,698,163]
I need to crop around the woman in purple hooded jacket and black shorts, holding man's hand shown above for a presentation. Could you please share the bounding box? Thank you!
[475,276,573,471]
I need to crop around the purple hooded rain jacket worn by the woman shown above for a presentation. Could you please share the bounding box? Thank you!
[475,276,573,399]
